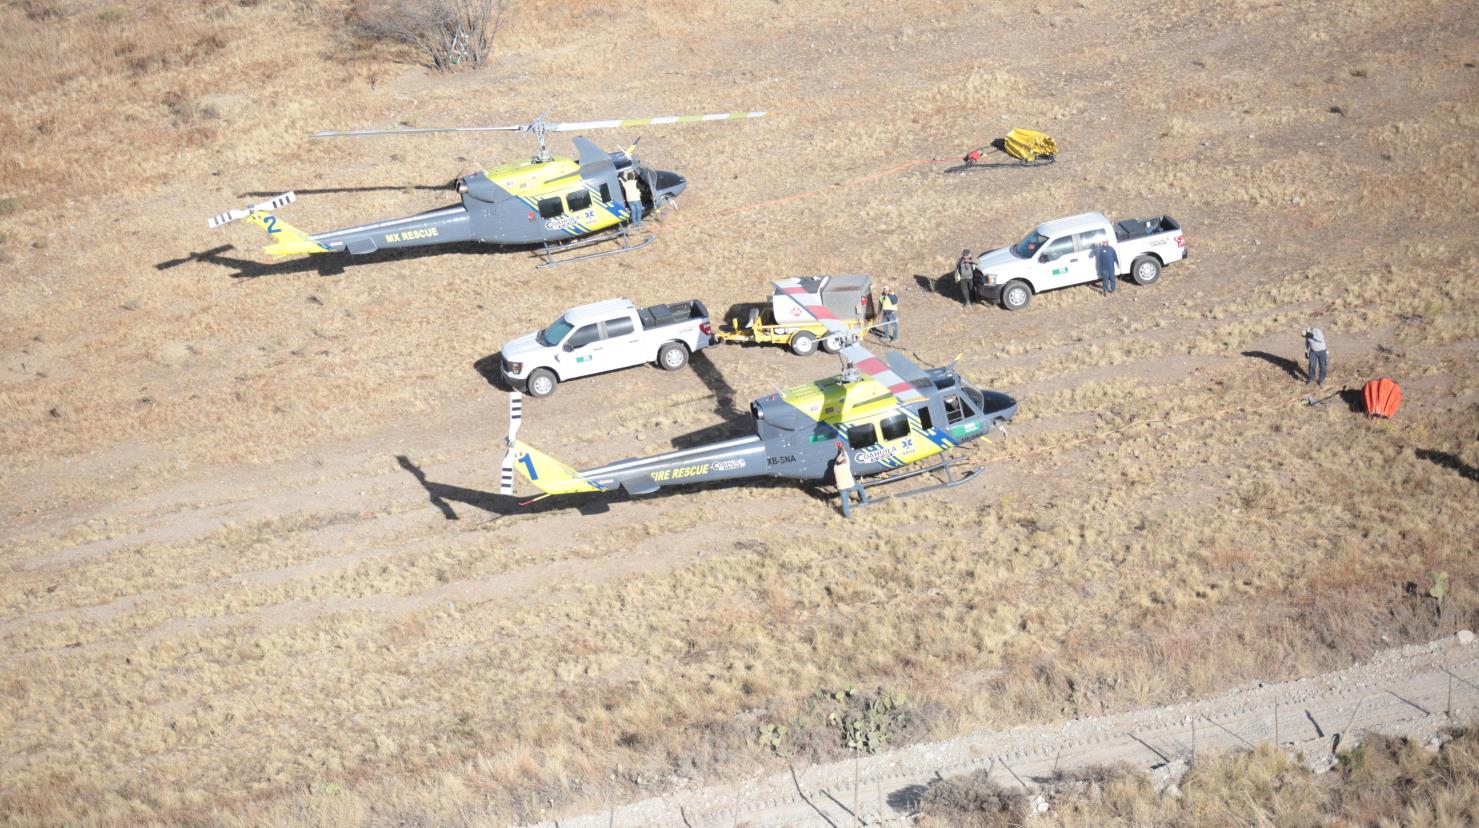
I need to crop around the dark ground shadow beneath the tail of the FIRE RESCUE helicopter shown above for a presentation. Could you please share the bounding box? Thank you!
[395,454,831,520]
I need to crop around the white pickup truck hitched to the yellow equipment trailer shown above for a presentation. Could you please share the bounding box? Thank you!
[498,299,714,396]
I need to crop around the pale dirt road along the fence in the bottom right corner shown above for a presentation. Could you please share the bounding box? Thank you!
[541,636,1479,828]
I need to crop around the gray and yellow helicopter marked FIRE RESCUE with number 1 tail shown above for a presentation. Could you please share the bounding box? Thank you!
[501,287,1018,500]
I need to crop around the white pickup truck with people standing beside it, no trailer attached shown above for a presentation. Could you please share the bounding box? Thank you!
[975,213,1186,311]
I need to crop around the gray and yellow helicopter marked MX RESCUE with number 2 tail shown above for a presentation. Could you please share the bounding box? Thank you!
[209,112,765,268]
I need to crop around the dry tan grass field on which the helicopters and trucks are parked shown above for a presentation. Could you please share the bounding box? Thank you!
[0,0,1479,825]
